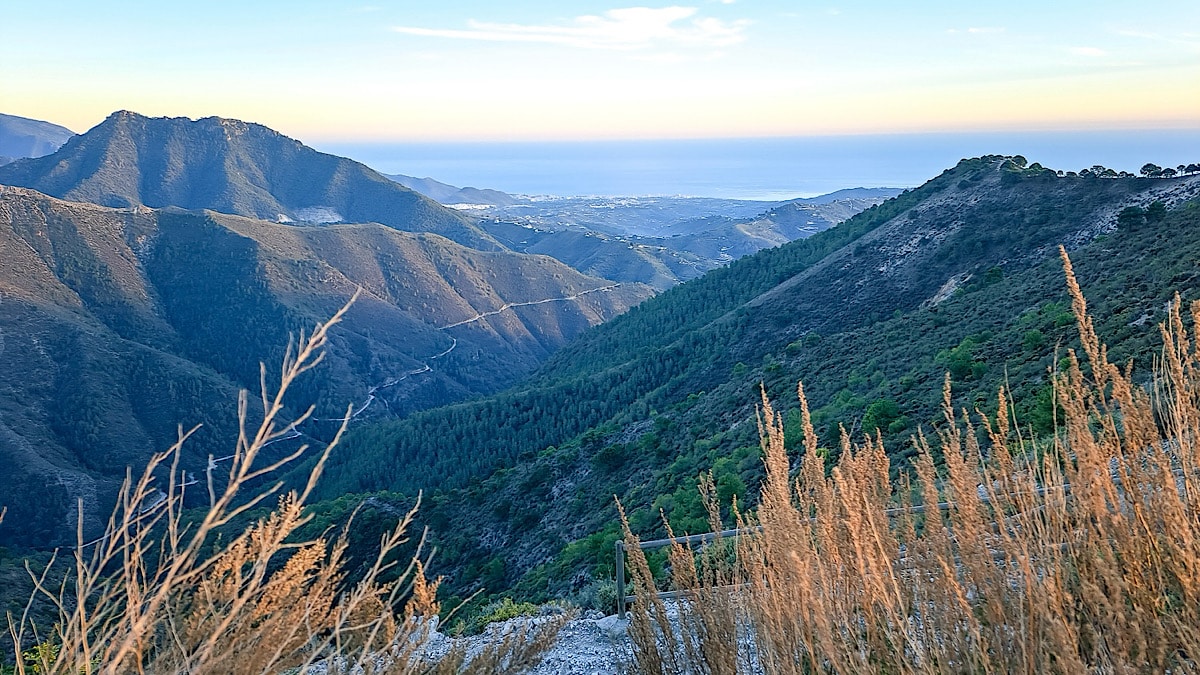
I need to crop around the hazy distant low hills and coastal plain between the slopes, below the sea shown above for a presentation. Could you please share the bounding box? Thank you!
[388,169,901,291]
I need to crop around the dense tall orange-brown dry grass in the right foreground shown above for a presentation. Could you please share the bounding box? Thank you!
[626,252,1200,674]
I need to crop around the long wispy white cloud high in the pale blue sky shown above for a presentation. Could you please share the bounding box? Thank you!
[392,7,750,50]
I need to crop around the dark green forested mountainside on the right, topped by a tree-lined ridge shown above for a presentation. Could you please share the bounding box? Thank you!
[304,156,1200,602]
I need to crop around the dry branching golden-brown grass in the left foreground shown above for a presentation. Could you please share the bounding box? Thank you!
[8,296,562,675]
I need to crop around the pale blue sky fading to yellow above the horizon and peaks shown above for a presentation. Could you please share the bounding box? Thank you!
[0,0,1200,143]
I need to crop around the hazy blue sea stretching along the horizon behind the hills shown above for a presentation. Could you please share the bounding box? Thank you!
[317,129,1200,201]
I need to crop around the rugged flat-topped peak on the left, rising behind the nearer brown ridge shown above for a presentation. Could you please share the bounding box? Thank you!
[0,110,499,250]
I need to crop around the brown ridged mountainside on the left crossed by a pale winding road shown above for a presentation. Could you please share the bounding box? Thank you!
[0,186,649,544]
